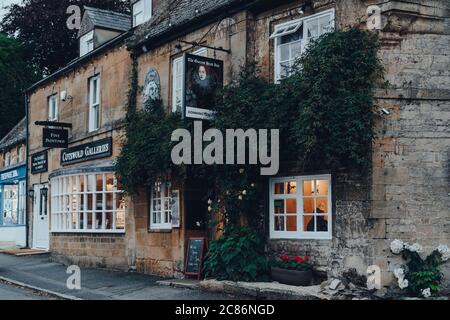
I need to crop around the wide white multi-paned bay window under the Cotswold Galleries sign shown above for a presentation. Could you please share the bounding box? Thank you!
[51,173,125,232]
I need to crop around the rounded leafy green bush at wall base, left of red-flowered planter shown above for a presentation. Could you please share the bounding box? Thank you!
[204,227,269,281]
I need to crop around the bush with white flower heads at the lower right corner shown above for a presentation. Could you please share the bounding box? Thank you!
[391,239,450,298]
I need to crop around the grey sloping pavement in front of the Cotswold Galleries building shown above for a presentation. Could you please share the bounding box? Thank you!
[0,253,242,300]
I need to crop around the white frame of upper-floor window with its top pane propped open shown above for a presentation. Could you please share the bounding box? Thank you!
[270,9,335,83]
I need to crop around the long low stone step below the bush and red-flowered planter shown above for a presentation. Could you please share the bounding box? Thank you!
[157,279,330,300]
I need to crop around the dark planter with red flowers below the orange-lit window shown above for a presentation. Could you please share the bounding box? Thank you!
[271,255,313,286]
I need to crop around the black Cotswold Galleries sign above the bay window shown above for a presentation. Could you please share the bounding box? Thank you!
[61,138,112,166]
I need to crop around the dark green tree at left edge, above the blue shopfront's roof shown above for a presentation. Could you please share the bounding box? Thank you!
[0,33,37,139]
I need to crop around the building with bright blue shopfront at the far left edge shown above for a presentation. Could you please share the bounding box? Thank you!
[0,118,27,247]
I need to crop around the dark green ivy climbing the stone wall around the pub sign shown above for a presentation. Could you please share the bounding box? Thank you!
[116,29,383,212]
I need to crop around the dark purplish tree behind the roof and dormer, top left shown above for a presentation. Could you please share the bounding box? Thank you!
[0,0,129,75]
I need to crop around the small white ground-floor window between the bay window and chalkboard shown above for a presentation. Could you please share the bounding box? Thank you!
[150,183,180,229]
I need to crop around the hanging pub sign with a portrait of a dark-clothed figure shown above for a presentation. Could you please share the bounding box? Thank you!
[184,54,223,120]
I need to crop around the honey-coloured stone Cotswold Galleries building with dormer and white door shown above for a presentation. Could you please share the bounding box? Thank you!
[27,8,132,269]
